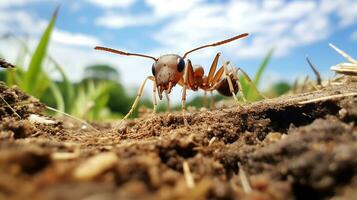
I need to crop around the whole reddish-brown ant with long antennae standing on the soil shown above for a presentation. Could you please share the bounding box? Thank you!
[94,33,252,124]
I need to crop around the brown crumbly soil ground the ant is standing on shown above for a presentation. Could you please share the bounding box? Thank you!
[0,80,357,200]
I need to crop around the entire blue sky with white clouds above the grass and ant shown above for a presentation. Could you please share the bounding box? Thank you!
[0,0,357,101]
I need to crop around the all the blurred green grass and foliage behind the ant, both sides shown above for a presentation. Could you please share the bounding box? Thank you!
[0,9,290,120]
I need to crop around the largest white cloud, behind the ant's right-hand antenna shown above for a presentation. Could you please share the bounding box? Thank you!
[147,0,340,60]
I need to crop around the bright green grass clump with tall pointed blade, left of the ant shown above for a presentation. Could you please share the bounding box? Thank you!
[2,8,117,120]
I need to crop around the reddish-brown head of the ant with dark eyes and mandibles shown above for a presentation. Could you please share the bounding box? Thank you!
[152,54,185,99]
